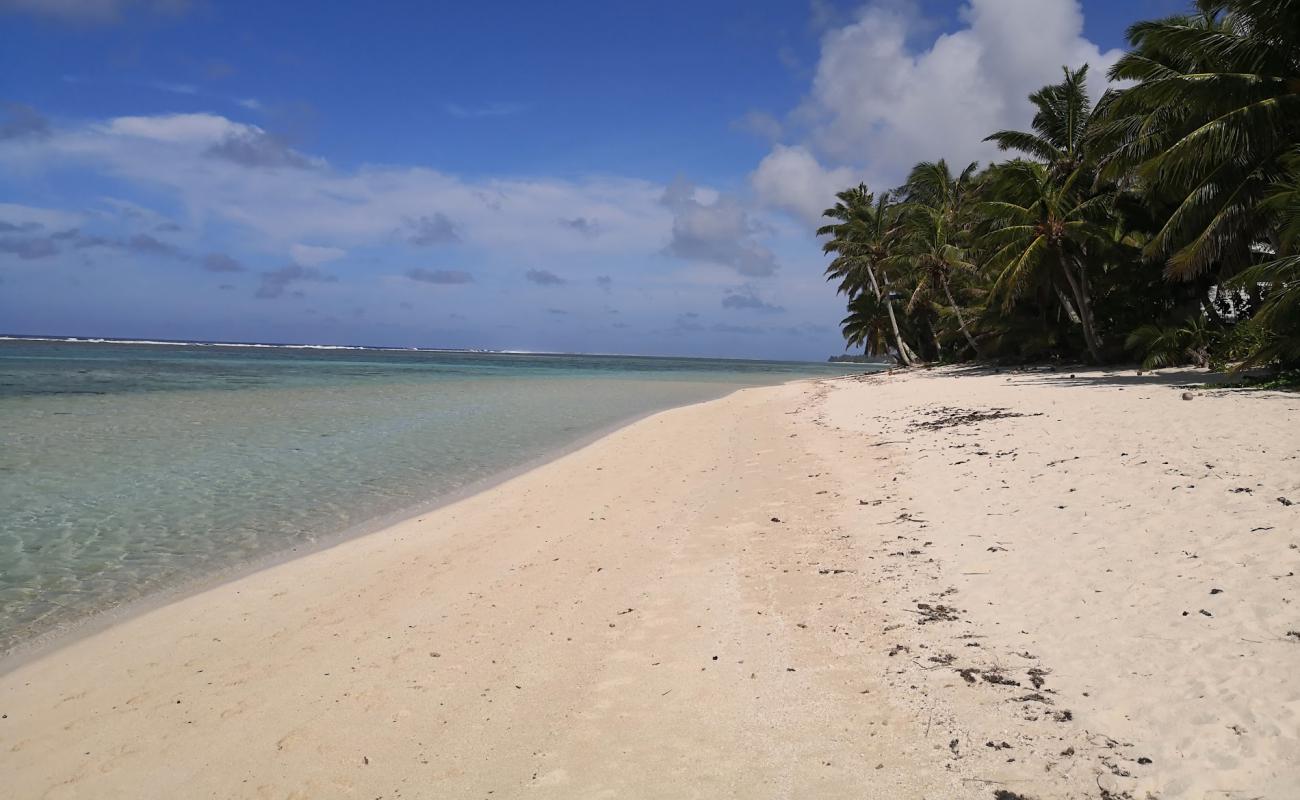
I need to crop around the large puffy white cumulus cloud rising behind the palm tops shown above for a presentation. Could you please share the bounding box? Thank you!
[751,0,1119,220]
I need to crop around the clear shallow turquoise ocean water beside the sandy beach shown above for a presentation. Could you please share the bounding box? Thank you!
[0,340,862,652]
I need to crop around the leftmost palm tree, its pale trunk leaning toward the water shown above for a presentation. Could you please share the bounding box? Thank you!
[816,183,915,367]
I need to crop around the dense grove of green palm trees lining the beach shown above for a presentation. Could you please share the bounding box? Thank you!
[818,0,1300,369]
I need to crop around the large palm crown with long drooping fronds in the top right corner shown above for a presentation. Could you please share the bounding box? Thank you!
[1096,0,1300,278]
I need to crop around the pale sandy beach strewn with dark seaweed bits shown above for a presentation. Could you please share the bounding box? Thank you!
[0,369,1300,800]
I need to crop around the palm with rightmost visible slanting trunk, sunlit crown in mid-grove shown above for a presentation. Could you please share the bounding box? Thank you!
[980,160,1110,363]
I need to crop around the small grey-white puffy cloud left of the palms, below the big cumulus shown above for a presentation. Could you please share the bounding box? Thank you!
[660,180,777,277]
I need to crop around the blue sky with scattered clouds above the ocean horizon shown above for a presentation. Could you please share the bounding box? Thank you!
[0,0,1182,360]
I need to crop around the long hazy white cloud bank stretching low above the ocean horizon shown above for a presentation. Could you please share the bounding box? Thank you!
[0,113,840,355]
